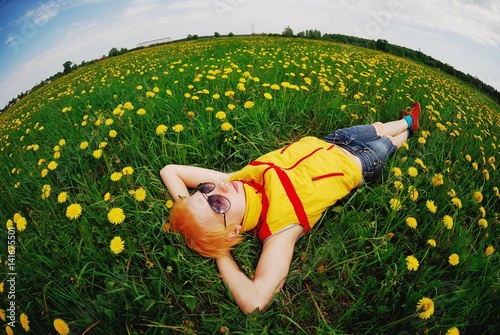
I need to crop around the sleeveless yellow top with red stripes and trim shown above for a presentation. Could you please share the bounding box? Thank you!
[231,136,362,242]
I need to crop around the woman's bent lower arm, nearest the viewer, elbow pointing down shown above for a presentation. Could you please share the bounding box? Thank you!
[216,226,303,313]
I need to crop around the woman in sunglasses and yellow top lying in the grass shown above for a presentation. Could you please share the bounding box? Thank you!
[160,102,420,313]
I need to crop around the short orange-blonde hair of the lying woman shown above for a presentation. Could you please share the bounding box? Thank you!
[170,199,243,258]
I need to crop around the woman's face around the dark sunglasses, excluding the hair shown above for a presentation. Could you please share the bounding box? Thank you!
[187,181,246,231]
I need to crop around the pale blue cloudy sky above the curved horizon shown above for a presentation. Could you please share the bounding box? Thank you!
[0,0,500,108]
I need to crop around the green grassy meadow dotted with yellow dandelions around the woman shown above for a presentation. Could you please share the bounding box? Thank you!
[0,37,500,335]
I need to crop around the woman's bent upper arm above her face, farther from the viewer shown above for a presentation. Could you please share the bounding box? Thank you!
[160,164,229,201]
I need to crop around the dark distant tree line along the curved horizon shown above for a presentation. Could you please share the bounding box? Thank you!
[0,26,500,114]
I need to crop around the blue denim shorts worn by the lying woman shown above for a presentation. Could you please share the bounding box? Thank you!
[323,125,397,182]
